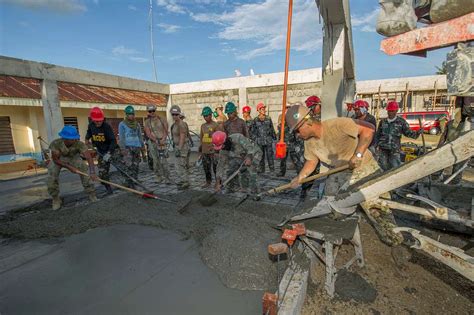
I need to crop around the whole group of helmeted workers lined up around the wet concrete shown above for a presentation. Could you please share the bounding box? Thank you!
[48,95,456,220]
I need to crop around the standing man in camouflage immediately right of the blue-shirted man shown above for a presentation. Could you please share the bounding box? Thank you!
[145,105,171,184]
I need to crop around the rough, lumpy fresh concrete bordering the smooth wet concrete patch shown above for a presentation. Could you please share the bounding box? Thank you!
[0,191,292,290]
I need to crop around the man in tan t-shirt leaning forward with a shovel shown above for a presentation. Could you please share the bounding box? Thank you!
[285,105,403,245]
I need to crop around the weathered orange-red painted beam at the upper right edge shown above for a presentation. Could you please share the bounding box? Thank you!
[380,12,474,56]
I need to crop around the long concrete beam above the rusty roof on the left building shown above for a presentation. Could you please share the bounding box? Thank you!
[0,56,169,94]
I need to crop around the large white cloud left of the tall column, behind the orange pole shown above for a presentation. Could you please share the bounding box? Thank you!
[191,0,322,59]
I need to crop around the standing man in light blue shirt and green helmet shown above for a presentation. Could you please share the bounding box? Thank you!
[119,105,144,188]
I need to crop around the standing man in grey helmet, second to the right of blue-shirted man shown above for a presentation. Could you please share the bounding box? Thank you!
[170,105,189,190]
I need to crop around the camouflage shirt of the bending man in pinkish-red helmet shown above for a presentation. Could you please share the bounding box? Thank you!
[216,133,263,178]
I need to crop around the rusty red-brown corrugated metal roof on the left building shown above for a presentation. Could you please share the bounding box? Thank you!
[0,75,168,106]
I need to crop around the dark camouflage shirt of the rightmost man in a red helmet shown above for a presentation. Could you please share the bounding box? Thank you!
[374,116,420,151]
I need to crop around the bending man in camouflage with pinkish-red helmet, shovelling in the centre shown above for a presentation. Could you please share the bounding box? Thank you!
[212,131,262,196]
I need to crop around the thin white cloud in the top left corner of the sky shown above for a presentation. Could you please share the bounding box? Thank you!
[0,0,87,13]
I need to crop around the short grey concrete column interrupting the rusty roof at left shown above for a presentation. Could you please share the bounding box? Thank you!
[41,79,64,142]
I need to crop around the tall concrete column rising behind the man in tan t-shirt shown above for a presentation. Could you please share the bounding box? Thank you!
[321,24,347,120]
